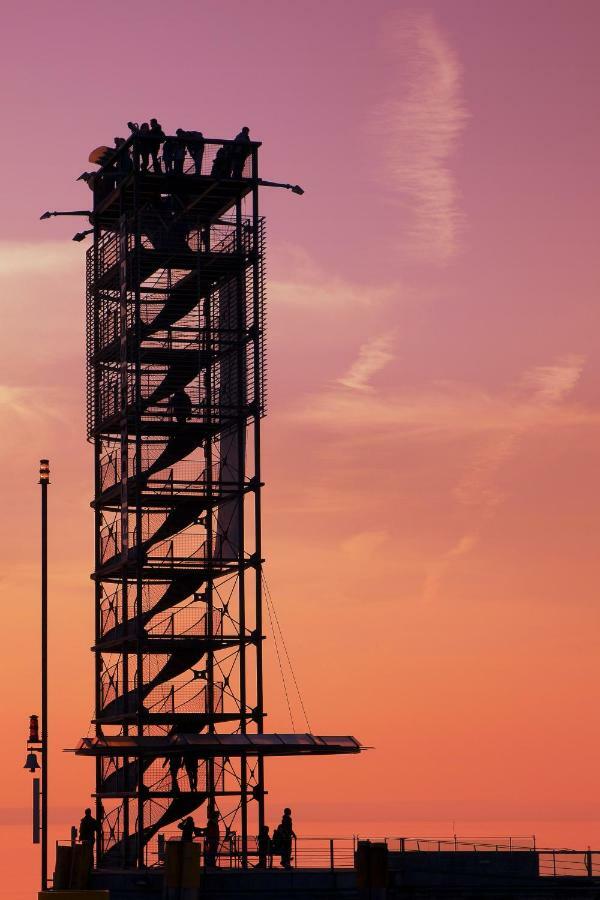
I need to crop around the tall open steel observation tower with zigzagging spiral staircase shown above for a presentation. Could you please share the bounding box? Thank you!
[65,135,360,869]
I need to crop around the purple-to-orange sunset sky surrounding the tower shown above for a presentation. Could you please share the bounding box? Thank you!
[0,0,600,896]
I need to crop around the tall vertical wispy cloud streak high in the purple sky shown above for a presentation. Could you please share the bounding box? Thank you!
[372,12,468,263]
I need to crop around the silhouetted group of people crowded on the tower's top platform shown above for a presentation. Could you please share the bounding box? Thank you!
[115,119,252,178]
